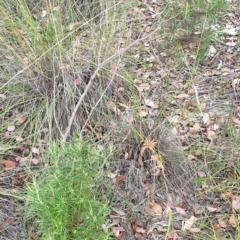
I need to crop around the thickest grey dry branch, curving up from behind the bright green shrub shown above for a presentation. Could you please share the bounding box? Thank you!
[62,16,176,142]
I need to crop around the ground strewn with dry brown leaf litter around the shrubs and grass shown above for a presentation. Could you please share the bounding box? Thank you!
[0,1,240,240]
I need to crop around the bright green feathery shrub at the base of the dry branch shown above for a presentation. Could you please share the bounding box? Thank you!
[25,141,110,240]
